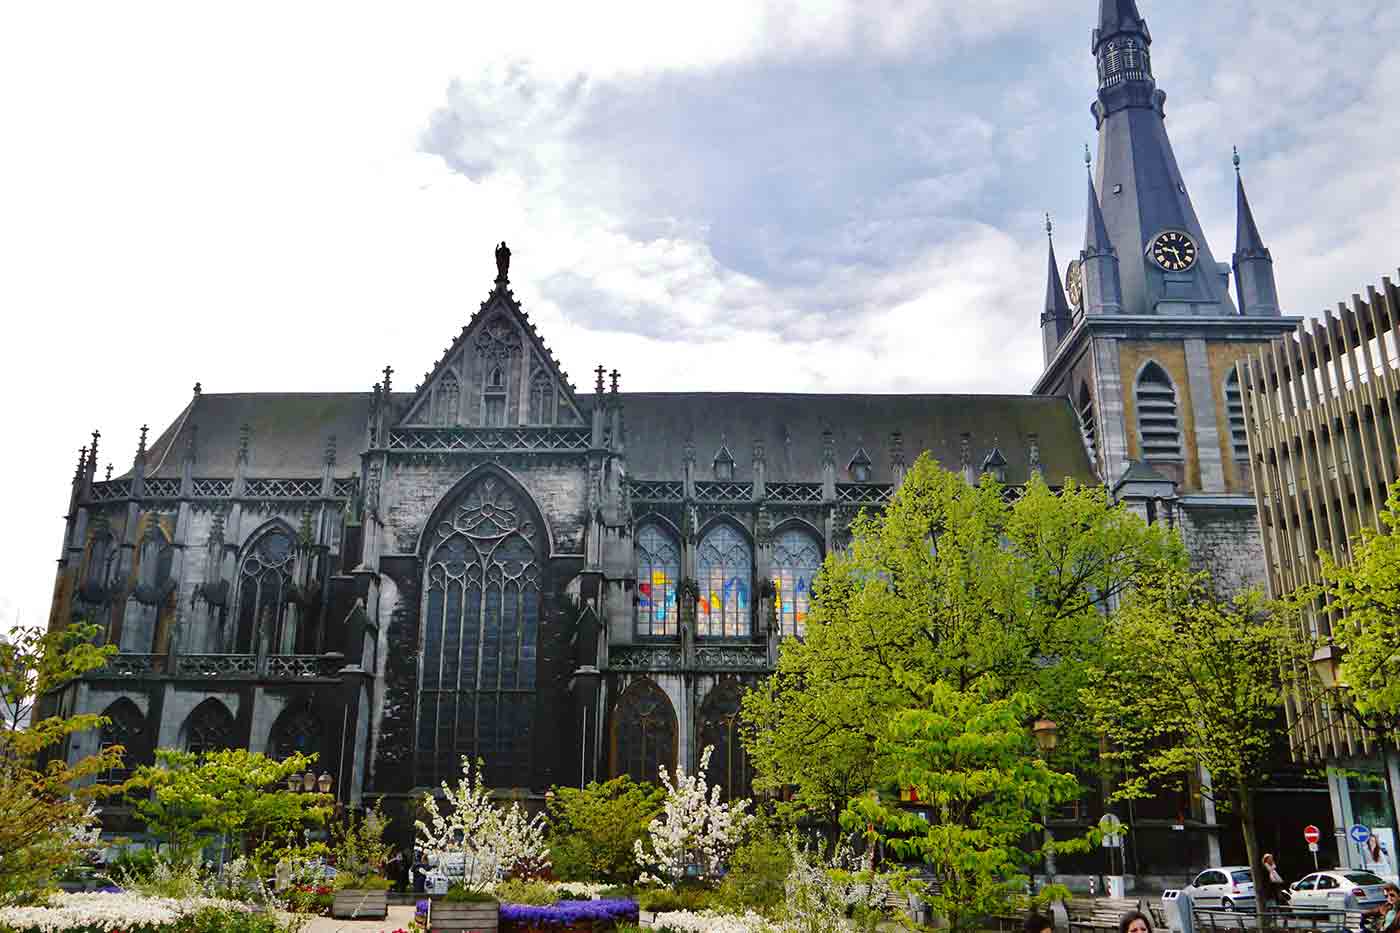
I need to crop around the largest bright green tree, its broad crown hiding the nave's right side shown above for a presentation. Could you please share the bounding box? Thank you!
[743,455,1184,822]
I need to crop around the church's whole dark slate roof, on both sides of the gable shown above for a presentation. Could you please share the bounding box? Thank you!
[128,392,1095,485]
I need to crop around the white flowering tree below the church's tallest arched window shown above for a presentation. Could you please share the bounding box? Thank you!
[416,755,549,891]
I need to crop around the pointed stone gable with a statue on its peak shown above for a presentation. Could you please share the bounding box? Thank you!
[399,252,584,427]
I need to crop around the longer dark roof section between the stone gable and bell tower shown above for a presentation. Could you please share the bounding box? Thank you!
[620,392,1096,485]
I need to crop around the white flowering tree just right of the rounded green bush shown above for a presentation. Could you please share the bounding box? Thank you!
[633,745,750,884]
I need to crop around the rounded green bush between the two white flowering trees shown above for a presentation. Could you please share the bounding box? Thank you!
[549,775,665,884]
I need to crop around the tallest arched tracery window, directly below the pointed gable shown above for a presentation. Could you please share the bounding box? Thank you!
[417,475,543,787]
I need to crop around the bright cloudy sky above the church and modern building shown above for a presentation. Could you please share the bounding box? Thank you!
[0,0,1400,630]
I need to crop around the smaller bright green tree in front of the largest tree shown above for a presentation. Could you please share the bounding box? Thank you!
[841,677,1088,932]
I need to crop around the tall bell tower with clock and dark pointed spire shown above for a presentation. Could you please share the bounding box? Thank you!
[1035,0,1296,582]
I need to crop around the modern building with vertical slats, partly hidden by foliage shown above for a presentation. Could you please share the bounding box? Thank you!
[1232,277,1400,849]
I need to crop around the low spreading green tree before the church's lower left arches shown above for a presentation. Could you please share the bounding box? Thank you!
[130,748,332,860]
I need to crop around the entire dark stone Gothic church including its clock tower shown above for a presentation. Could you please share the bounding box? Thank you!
[50,0,1327,879]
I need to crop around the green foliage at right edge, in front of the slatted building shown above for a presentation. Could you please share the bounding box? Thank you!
[1323,482,1400,733]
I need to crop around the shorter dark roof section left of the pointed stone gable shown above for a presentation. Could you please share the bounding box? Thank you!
[147,392,378,478]
